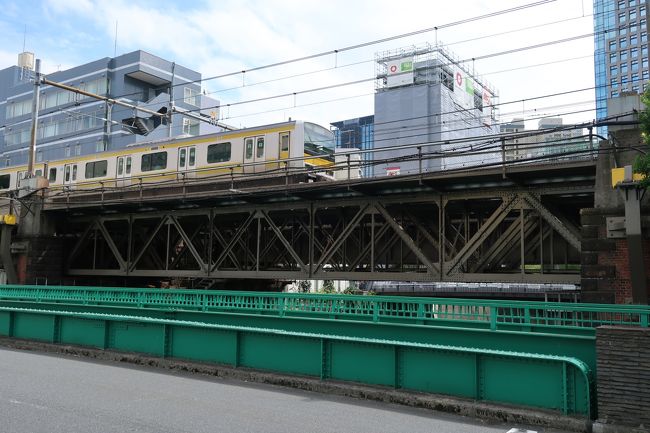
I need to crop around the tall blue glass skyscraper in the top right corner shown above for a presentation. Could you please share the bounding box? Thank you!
[594,0,650,136]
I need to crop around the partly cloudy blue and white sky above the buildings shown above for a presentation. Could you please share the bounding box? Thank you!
[0,0,595,128]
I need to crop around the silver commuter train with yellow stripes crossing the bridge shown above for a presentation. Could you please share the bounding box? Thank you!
[0,121,335,190]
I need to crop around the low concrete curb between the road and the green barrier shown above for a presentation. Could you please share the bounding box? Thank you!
[0,337,588,433]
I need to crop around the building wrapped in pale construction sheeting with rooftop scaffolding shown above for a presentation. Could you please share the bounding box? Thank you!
[374,44,501,174]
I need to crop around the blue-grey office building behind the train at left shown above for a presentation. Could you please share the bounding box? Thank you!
[0,51,219,166]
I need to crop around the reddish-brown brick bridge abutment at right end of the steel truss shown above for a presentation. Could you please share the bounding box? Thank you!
[580,209,650,304]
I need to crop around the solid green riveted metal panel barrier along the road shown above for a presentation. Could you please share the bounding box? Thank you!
[0,306,594,418]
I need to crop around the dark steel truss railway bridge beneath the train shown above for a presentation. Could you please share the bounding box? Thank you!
[43,160,596,284]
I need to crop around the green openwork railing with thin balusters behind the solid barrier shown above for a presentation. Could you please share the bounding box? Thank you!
[0,285,650,330]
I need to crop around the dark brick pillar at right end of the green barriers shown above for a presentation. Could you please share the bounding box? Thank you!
[596,326,650,427]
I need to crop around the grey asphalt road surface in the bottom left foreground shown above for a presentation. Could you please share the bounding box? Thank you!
[0,348,568,433]
